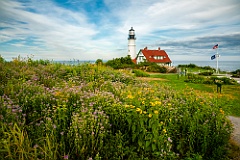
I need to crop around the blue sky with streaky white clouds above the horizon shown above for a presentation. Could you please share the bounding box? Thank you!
[0,0,240,62]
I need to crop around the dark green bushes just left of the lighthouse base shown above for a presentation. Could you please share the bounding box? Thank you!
[105,56,135,69]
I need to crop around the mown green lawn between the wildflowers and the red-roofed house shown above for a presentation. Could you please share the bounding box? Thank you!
[150,74,240,117]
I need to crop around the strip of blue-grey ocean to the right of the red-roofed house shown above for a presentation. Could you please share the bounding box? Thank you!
[172,61,240,72]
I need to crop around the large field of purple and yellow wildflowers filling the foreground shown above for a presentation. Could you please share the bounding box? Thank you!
[0,58,232,160]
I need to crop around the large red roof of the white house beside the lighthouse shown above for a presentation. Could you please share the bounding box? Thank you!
[141,47,172,63]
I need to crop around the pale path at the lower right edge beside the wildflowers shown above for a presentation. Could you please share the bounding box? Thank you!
[228,116,240,146]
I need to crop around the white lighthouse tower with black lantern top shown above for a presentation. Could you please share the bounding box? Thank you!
[128,27,136,59]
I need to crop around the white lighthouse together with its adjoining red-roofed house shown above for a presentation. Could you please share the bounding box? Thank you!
[128,27,172,66]
